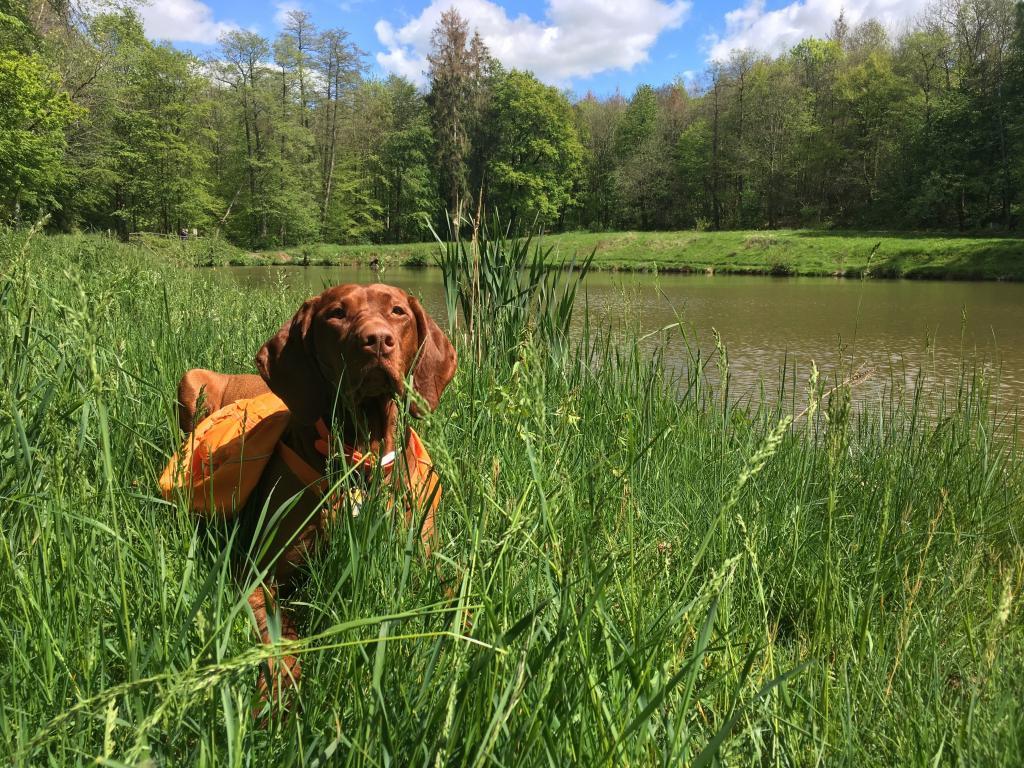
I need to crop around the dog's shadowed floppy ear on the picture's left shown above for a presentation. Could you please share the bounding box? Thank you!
[256,296,331,424]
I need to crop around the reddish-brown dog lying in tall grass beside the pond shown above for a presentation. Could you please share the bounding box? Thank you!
[178,285,456,693]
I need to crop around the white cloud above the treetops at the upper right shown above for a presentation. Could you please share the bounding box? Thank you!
[708,0,931,60]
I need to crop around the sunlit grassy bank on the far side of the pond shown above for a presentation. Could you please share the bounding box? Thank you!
[180,229,1024,281]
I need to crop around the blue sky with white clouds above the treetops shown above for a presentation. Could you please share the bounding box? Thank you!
[140,0,928,95]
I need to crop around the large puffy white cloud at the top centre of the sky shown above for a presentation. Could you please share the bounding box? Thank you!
[374,0,691,85]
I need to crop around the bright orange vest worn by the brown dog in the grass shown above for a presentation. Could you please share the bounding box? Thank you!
[160,392,440,519]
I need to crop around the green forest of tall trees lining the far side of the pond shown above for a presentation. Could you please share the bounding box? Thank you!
[0,0,1024,248]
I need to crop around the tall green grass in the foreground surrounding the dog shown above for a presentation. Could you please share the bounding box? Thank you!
[6,234,1024,766]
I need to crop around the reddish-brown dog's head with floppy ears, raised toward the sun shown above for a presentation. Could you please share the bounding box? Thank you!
[256,284,456,423]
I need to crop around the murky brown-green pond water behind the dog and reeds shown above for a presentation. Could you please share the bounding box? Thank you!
[218,267,1024,412]
